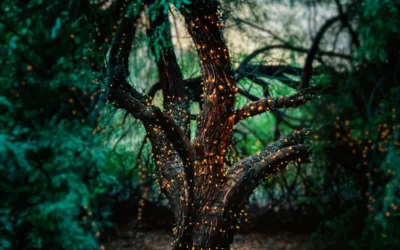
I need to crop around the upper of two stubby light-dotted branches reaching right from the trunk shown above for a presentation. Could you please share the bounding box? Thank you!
[234,88,316,123]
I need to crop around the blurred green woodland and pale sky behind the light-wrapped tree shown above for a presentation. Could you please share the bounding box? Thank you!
[0,0,400,249]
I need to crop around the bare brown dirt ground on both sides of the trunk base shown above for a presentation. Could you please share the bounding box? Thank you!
[103,230,308,250]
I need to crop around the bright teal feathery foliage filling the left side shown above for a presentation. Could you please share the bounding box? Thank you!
[0,1,124,250]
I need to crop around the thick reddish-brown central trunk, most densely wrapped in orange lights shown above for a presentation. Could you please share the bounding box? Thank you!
[170,1,237,249]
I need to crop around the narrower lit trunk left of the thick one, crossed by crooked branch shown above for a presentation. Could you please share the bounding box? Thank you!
[146,4,194,244]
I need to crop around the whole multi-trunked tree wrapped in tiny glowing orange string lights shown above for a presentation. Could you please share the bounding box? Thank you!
[104,0,324,249]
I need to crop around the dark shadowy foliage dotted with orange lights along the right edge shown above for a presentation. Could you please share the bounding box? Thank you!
[304,1,400,249]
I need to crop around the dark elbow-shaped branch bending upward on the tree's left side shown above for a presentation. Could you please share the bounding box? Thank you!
[106,2,194,172]
